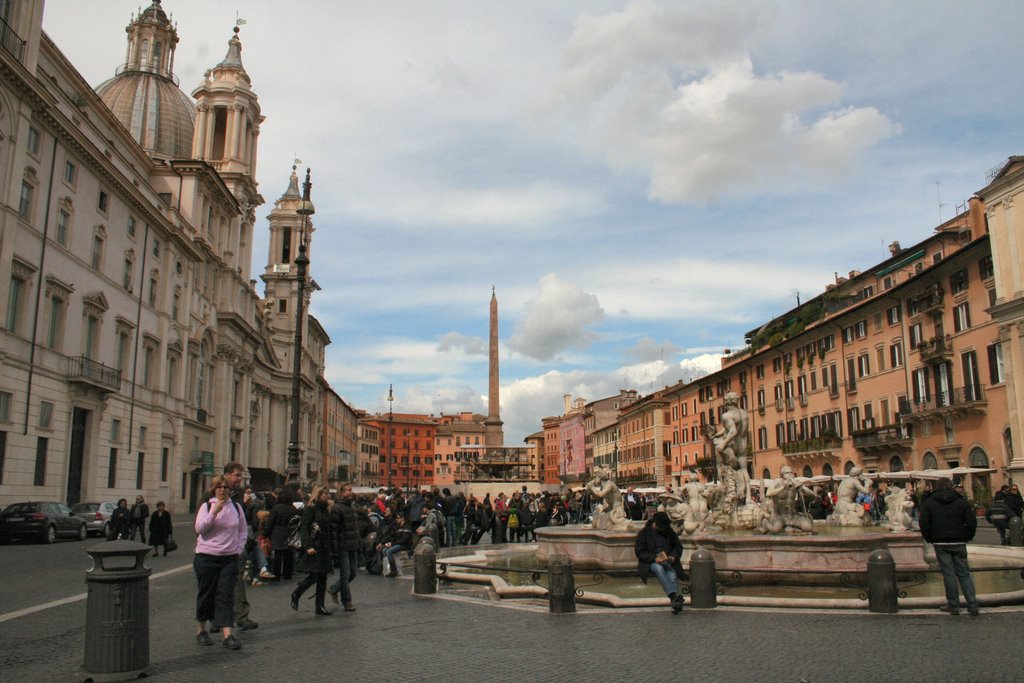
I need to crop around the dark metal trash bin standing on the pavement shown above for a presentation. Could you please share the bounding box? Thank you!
[80,541,151,683]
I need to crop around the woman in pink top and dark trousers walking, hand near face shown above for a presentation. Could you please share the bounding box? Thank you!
[193,474,248,650]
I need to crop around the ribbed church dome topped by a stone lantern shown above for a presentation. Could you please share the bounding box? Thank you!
[96,0,196,159]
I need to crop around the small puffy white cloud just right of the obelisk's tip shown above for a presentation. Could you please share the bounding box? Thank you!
[508,273,605,360]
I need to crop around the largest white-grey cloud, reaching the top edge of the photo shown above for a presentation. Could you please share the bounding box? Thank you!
[548,2,898,205]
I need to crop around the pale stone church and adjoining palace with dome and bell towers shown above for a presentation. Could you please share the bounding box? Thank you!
[0,0,330,511]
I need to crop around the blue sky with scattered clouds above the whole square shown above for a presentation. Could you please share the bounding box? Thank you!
[43,0,1024,444]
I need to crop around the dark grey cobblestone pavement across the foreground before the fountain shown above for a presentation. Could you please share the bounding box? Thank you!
[0,554,1024,683]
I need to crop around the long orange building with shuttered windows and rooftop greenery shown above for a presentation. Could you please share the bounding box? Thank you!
[663,200,1009,498]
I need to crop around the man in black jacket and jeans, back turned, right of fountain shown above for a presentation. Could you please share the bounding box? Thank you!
[921,478,978,616]
